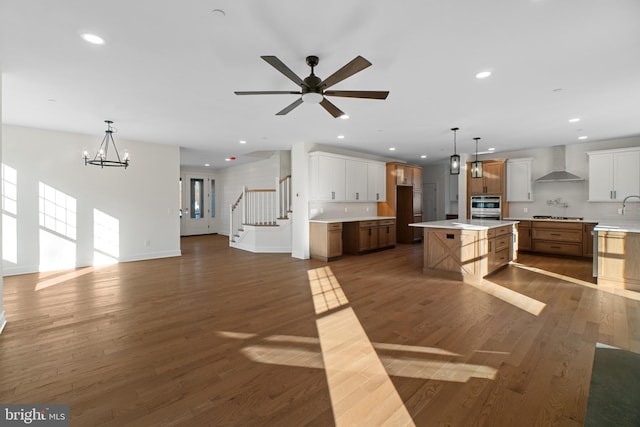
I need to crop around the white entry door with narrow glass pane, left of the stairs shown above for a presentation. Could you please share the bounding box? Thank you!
[180,174,216,236]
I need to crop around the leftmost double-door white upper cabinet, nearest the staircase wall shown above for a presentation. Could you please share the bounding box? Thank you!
[309,155,346,201]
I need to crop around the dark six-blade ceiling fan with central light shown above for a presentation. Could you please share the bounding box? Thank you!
[235,55,389,117]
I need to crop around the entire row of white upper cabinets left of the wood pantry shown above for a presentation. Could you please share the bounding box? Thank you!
[309,152,386,202]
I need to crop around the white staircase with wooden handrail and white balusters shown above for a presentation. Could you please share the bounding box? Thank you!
[229,175,292,253]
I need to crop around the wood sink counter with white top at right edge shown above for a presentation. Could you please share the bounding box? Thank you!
[593,220,640,291]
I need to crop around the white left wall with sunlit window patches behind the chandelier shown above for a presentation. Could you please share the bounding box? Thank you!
[3,125,180,275]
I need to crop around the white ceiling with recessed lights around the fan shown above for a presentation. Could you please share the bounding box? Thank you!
[0,0,640,167]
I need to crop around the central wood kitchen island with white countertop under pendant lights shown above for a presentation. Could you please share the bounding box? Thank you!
[409,219,518,283]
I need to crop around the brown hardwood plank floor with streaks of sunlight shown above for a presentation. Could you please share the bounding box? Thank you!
[0,236,640,426]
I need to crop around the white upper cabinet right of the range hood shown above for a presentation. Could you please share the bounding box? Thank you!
[587,147,640,202]
